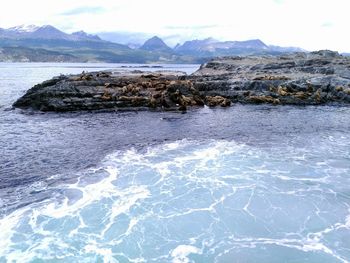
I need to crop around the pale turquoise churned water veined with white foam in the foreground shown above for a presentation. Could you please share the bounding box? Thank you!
[0,137,350,262]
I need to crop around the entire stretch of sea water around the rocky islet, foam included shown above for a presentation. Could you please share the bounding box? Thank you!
[0,64,350,263]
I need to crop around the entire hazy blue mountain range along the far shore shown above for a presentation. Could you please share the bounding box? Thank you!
[0,25,303,63]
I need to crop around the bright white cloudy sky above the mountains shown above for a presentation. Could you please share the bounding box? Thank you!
[0,0,350,52]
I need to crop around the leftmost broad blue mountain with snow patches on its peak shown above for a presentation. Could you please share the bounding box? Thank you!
[0,25,134,63]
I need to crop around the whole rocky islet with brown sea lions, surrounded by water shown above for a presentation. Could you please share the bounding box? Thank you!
[14,50,350,112]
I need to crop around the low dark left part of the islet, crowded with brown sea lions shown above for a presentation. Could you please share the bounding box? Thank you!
[14,72,219,112]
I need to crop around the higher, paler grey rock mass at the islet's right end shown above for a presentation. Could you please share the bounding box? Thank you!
[192,50,350,105]
